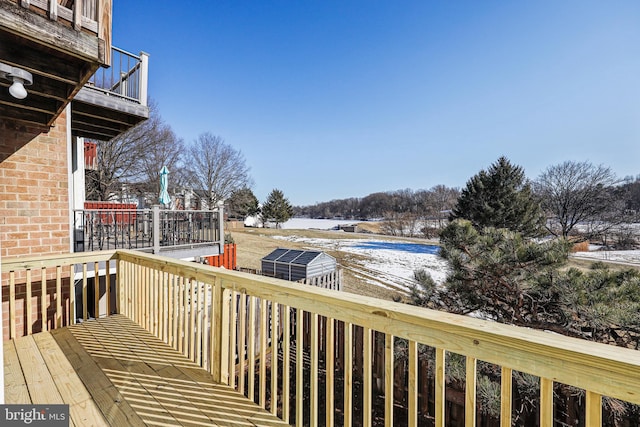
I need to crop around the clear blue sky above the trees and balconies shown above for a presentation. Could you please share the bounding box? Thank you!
[113,0,640,205]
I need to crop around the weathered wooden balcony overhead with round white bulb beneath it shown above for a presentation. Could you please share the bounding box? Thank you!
[0,0,111,130]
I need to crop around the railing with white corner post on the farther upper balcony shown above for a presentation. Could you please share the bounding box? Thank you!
[85,46,149,105]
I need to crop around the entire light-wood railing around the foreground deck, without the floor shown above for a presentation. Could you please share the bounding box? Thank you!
[2,250,640,426]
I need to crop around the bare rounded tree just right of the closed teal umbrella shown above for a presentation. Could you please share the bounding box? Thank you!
[188,132,252,208]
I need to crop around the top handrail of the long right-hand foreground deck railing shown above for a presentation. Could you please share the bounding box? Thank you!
[118,251,640,404]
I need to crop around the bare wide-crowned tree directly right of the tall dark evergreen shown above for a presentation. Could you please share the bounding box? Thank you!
[535,161,620,238]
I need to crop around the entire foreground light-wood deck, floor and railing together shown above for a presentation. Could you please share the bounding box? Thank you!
[2,250,640,427]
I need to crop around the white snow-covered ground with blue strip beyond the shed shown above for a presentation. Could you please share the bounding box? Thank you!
[274,218,448,292]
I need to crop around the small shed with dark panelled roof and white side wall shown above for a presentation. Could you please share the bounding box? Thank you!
[262,248,337,282]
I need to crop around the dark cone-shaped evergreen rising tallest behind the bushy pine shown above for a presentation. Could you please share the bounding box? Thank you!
[451,157,544,237]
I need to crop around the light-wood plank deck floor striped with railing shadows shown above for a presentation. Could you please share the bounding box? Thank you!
[4,315,286,426]
